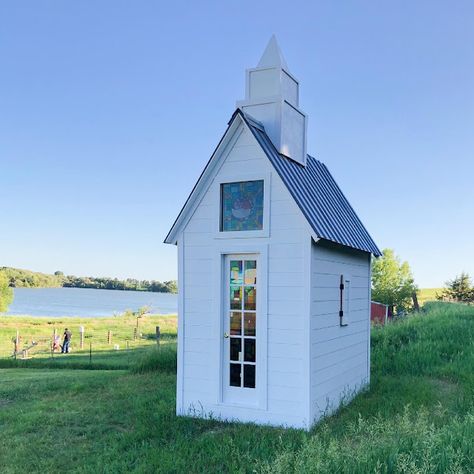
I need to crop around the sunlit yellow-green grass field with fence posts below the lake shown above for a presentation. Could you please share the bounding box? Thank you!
[0,315,176,369]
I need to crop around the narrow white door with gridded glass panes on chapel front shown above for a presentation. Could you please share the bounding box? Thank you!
[222,254,259,404]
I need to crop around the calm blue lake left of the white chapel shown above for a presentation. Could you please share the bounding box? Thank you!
[4,288,178,317]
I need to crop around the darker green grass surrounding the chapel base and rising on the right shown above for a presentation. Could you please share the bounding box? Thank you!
[0,303,474,473]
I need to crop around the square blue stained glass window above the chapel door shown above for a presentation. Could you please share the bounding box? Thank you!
[221,180,263,231]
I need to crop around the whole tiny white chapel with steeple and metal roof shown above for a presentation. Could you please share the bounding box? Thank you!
[165,37,381,429]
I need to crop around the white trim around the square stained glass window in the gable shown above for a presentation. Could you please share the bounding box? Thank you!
[212,173,271,239]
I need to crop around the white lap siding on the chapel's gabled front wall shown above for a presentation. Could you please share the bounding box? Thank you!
[180,124,309,424]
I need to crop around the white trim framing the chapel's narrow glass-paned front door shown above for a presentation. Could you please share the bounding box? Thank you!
[213,243,268,410]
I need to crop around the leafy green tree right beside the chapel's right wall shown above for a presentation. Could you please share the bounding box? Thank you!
[372,249,417,313]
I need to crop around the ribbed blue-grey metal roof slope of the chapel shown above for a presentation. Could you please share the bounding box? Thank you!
[241,110,382,257]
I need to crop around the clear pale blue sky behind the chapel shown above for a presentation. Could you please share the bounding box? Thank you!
[0,0,474,286]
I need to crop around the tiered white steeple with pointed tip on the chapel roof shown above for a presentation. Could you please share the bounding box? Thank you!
[237,35,307,165]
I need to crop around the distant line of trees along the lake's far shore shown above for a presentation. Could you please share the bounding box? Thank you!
[0,267,178,293]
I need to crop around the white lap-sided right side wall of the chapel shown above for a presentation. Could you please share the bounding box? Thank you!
[311,244,370,420]
